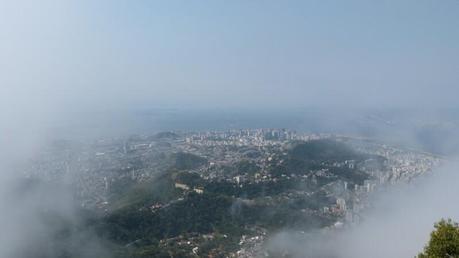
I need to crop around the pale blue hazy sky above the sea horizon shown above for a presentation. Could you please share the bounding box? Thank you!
[0,0,459,114]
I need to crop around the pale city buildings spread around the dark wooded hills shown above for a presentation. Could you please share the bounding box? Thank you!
[21,129,441,257]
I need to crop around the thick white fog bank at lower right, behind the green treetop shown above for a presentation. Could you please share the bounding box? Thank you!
[268,162,459,258]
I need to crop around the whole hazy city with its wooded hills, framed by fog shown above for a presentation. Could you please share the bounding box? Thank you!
[18,129,441,257]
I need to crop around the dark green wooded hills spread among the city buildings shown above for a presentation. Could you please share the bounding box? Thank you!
[17,139,380,257]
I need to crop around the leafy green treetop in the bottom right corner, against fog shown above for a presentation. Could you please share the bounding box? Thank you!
[418,219,459,258]
